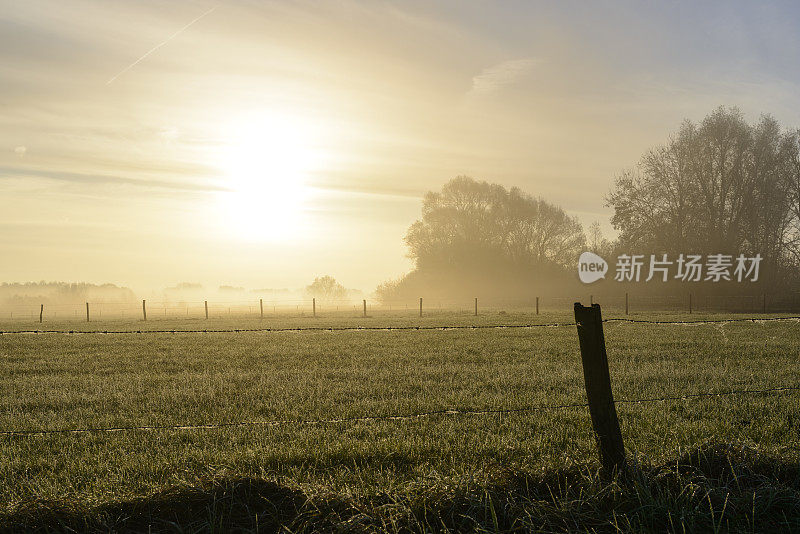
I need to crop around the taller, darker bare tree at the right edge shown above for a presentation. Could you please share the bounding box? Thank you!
[607,108,800,286]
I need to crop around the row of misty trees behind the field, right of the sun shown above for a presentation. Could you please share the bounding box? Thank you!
[377,107,800,300]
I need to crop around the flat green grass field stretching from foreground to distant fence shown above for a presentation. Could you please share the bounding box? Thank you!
[0,312,800,532]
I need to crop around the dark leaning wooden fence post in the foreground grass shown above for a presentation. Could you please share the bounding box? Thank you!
[575,302,625,477]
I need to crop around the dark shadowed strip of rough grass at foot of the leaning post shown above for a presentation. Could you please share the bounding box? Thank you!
[0,444,800,532]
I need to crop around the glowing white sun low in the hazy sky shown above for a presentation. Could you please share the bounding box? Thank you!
[218,114,319,241]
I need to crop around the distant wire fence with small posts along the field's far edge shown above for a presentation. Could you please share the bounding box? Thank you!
[0,293,800,323]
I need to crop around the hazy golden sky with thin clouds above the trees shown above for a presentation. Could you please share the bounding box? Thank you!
[0,0,800,293]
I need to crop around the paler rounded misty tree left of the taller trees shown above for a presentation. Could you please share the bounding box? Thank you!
[377,176,586,301]
